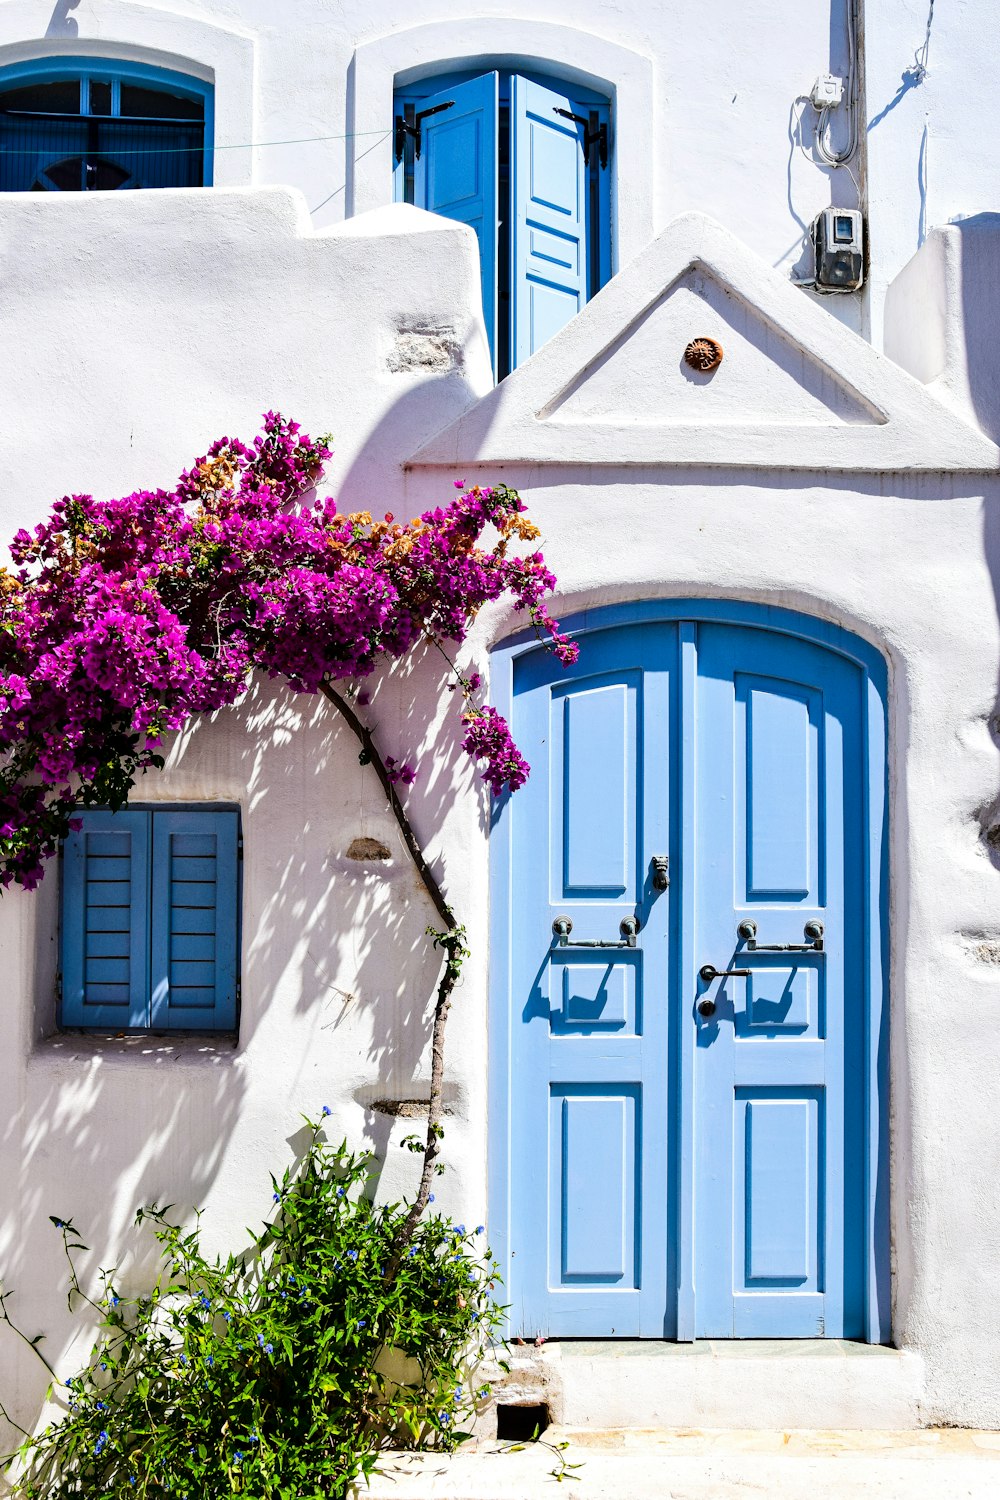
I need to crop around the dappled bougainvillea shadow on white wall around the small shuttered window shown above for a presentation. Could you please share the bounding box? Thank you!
[0,597,486,1451]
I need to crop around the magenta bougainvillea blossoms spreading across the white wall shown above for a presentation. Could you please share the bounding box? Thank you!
[0,413,576,888]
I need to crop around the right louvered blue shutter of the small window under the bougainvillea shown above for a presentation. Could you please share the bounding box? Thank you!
[150,810,240,1031]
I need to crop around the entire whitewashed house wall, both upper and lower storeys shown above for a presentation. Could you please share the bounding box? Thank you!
[0,0,1000,1446]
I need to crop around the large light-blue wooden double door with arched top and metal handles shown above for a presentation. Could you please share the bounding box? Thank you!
[503,621,877,1338]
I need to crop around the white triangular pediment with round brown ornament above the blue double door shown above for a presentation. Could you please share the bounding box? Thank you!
[411,215,1000,471]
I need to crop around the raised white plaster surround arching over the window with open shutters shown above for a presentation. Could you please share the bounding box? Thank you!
[348,17,663,269]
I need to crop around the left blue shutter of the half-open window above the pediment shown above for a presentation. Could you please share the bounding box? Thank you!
[414,74,499,369]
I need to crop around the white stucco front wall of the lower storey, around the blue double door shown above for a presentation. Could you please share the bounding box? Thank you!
[0,189,1000,1427]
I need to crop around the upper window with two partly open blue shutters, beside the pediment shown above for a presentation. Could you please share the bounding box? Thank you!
[394,72,612,380]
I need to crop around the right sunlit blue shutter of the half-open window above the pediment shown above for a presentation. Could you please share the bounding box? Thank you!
[510,75,610,366]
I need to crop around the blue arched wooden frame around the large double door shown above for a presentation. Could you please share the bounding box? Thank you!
[487,599,891,1344]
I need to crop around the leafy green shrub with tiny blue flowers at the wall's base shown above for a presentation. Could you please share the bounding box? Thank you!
[3,1110,499,1500]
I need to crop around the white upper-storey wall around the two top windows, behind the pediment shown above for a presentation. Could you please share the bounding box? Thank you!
[0,0,1000,344]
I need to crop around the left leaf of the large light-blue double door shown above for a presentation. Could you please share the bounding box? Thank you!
[508,626,676,1338]
